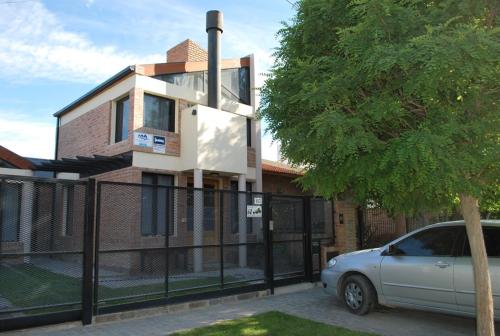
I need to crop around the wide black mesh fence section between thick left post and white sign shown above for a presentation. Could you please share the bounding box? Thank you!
[94,179,267,314]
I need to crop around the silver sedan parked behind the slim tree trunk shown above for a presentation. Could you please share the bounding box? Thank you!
[321,220,500,320]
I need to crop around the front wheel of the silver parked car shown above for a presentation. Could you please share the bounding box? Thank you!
[342,275,376,315]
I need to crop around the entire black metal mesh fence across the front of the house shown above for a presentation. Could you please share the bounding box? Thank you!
[0,176,334,330]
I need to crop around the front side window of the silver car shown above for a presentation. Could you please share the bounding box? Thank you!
[395,226,460,257]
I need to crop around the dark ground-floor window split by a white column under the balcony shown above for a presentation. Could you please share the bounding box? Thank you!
[187,183,215,231]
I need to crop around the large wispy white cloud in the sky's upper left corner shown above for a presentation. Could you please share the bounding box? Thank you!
[0,2,163,83]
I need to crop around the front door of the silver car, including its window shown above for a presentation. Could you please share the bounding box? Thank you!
[380,226,460,310]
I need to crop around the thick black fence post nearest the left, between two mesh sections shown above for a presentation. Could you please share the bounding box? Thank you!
[82,179,96,325]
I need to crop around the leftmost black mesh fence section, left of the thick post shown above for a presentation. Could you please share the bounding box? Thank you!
[0,175,91,331]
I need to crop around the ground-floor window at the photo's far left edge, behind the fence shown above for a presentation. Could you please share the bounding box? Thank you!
[0,183,22,242]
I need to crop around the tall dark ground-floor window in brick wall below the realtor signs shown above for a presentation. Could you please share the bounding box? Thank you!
[141,173,174,236]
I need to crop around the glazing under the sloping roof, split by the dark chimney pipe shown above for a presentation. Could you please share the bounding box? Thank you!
[155,67,250,105]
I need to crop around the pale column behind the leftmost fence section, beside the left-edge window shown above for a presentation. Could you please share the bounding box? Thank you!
[19,181,35,263]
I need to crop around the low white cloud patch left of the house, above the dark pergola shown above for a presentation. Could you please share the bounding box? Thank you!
[0,111,55,159]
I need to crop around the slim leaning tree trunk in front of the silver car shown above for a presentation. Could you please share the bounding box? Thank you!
[460,194,495,336]
